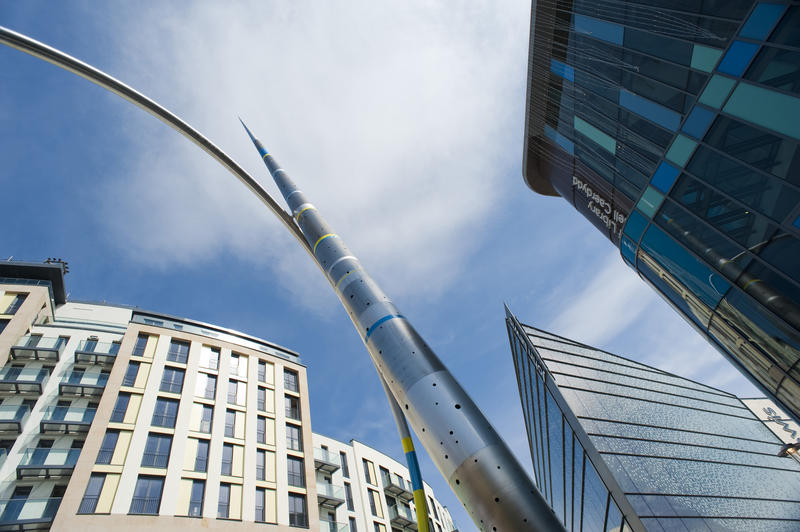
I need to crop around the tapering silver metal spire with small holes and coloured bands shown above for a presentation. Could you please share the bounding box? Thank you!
[242,123,564,532]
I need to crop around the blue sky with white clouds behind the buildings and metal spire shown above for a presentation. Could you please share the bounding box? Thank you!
[0,1,757,530]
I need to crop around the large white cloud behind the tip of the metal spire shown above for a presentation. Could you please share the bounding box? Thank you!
[92,1,529,306]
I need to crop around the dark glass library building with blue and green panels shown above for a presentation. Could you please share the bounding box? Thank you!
[523,0,800,417]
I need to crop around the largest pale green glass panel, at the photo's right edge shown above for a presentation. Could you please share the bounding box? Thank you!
[724,83,800,139]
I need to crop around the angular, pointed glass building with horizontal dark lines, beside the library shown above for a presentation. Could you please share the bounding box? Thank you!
[506,312,800,532]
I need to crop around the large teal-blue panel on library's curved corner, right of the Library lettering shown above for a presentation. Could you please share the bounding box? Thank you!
[641,225,730,308]
